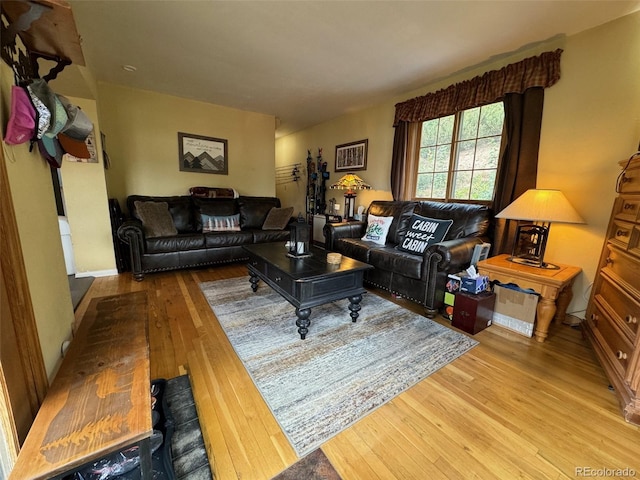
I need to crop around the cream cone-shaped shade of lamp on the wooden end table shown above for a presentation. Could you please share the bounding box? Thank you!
[496,188,585,223]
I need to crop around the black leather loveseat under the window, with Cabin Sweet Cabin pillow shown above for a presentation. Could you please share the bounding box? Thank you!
[324,201,490,317]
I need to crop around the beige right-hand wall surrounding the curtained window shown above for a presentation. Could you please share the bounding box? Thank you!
[276,13,640,317]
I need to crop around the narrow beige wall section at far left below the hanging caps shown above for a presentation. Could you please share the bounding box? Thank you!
[0,62,74,379]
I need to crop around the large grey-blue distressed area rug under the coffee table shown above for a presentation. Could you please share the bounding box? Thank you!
[200,277,477,457]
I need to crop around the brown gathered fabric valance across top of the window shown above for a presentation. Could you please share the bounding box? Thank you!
[393,49,562,126]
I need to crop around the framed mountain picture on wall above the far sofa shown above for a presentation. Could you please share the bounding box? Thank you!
[178,132,229,175]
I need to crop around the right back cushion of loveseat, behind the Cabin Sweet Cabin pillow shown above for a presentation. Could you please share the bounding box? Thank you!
[415,201,489,241]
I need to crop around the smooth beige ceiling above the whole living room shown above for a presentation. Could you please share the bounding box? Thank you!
[69,0,640,137]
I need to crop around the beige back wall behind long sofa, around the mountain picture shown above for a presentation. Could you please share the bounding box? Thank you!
[98,83,275,209]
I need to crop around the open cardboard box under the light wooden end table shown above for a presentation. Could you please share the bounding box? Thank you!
[493,284,538,337]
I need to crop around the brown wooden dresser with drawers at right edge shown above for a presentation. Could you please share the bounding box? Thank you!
[585,158,640,425]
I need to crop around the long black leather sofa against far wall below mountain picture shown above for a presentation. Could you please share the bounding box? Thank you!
[117,195,289,281]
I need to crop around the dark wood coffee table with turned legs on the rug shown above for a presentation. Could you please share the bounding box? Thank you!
[244,242,373,340]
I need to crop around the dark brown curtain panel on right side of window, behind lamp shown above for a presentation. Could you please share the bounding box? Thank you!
[492,87,544,255]
